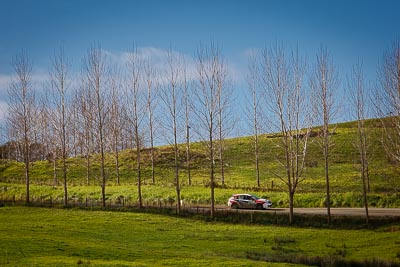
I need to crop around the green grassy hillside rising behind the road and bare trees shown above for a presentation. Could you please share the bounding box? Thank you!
[0,120,400,207]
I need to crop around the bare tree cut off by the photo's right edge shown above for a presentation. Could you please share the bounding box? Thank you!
[375,40,400,192]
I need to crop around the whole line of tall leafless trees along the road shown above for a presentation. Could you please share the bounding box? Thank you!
[3,41,400,223]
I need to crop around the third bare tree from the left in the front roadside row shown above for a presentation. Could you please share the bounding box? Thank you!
[84,47,109,207]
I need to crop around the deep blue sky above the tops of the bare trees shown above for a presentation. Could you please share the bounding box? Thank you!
[0,0,400,122]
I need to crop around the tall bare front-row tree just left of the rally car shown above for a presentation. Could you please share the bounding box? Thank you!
[193,42,223,218]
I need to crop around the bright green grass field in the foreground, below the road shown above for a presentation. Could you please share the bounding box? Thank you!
[0,207,400,266]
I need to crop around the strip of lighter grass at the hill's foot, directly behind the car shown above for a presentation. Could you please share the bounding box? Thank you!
[0,183,400,208]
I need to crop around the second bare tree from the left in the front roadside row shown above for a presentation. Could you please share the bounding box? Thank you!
[50,47,70,206]
